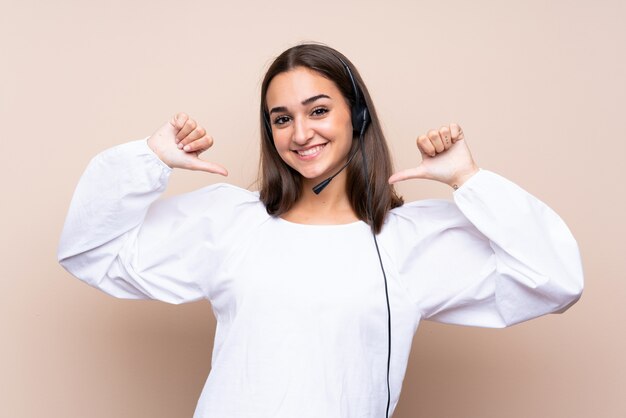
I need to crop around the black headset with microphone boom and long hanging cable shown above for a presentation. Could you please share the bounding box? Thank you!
[263,56,391,418]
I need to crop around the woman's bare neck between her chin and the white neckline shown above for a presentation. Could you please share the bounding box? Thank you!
[281,171,359,225]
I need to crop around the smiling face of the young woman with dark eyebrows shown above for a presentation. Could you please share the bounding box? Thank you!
[266,67,352,184]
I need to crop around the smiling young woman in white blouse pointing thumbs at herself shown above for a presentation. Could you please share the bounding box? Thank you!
[58,44,583,418]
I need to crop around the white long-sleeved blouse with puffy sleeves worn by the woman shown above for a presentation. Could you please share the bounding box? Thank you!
[58,139,583,418]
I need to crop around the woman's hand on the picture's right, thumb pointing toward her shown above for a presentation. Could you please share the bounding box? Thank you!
[389,123,479,189]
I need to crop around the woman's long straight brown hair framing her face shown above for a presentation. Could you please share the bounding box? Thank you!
[260,44,404,233]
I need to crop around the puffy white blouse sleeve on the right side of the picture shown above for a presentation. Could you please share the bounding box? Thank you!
[382,169,583,328]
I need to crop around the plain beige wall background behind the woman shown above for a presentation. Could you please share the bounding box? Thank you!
[0,0,626,418]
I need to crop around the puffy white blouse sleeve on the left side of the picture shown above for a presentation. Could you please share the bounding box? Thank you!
[57,138,244,304]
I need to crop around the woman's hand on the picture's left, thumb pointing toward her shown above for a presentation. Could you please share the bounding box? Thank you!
[148,113,228,176]
